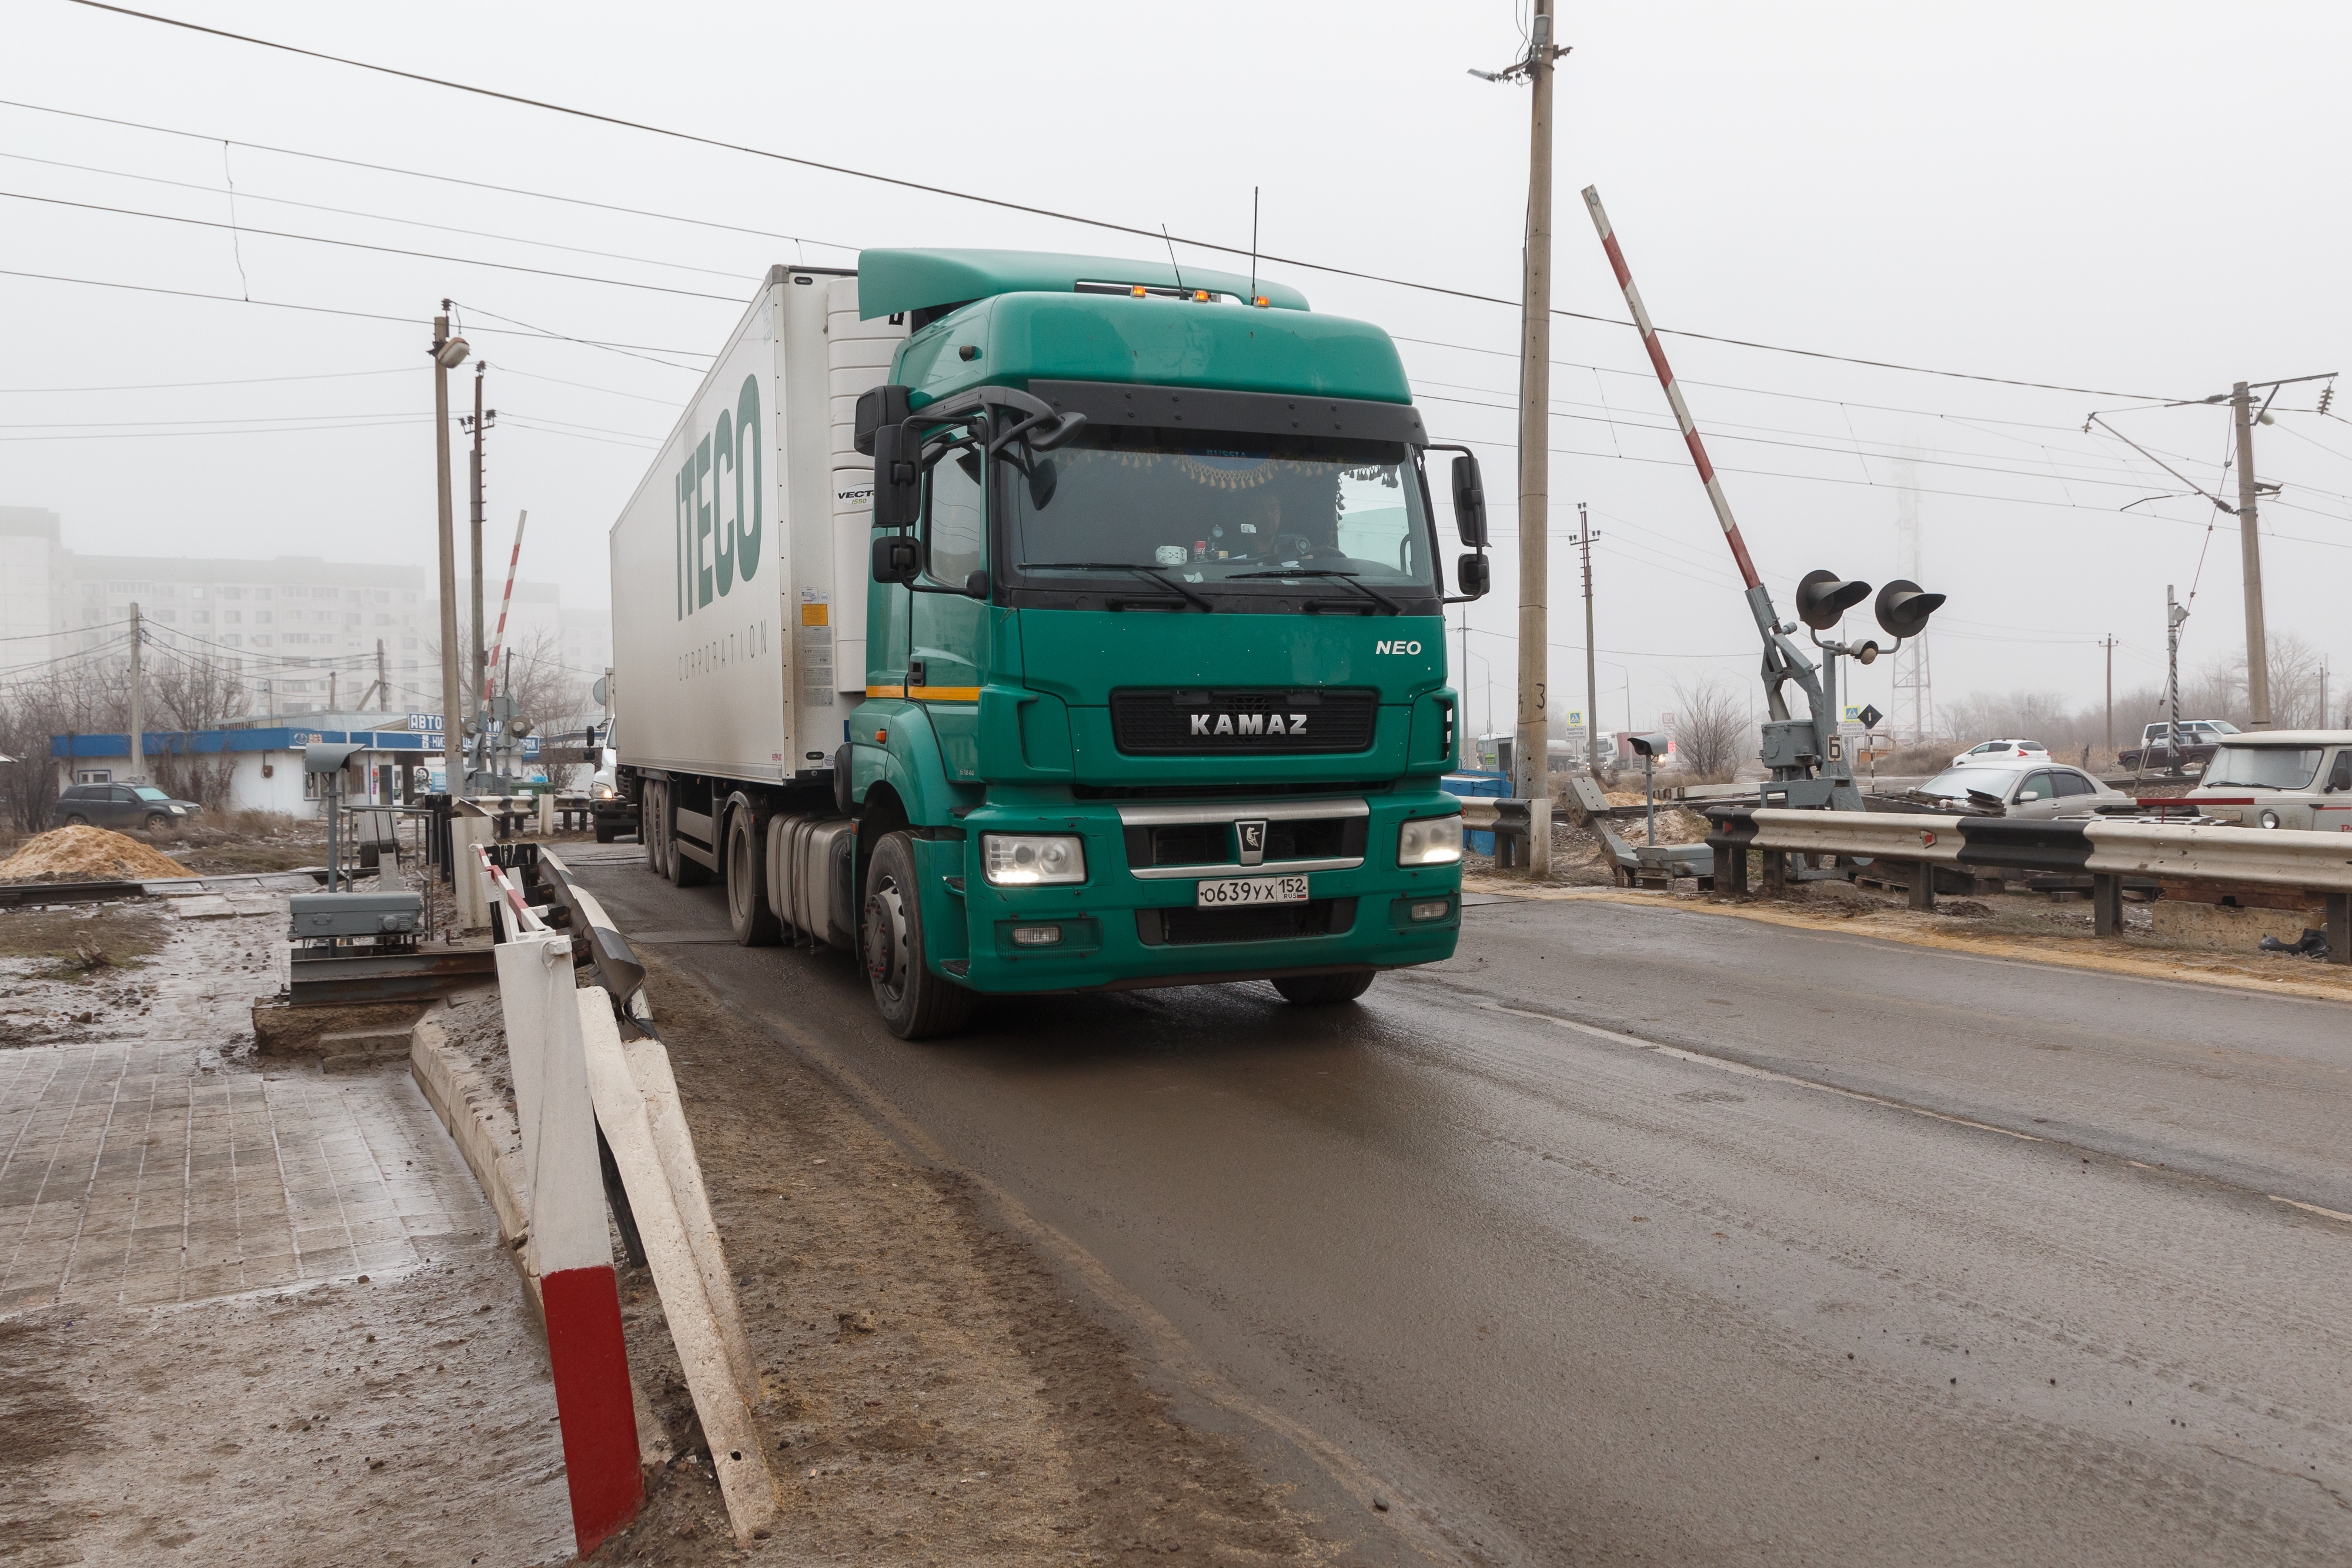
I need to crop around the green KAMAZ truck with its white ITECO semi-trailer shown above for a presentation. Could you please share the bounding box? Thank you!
[612,249,1486,1037]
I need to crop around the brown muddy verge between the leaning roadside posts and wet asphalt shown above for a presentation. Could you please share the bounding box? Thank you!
[576,954,1355,1566]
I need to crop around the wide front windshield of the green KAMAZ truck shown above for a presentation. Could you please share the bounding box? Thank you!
[1007,430,1432,597]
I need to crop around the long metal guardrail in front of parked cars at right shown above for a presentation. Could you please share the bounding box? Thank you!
[1708,806,2352,964]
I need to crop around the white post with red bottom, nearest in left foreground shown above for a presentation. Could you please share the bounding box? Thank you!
[475,851,644,1556]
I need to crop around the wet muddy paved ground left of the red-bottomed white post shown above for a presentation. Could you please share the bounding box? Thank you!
[0,895,572,1568]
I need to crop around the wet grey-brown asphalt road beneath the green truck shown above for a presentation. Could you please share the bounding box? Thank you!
[569,862,2352,1563]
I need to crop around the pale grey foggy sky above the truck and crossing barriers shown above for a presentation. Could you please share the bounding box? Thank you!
[0,0,2352,727]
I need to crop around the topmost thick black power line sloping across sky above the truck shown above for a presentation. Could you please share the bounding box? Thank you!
[55,0,2164,402]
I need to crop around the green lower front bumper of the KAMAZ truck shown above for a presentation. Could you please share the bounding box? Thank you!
[917,785,1461,994]
